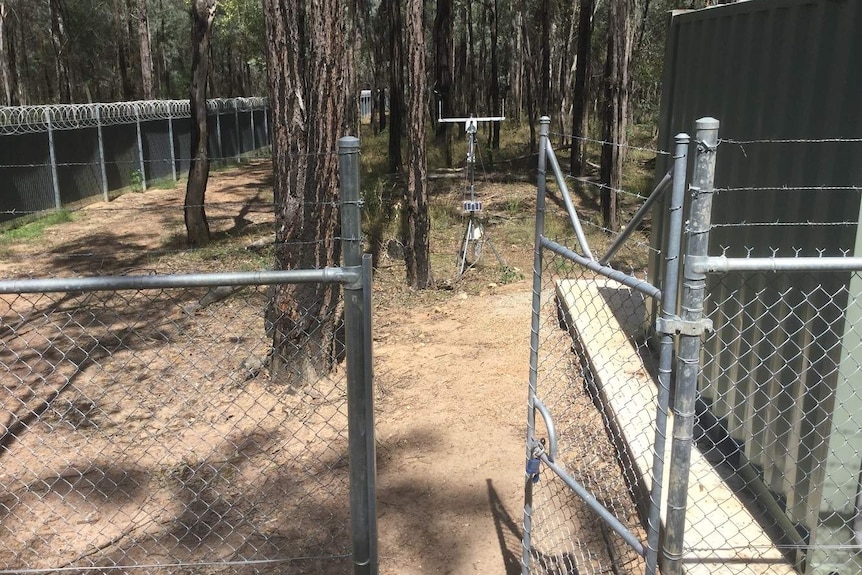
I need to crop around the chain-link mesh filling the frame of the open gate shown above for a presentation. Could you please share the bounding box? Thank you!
[531,217,656,575]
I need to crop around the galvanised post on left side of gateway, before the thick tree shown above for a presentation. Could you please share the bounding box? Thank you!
[338,136,378,575]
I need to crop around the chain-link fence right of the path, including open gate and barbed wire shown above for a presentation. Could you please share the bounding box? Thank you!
[523,118,862,575]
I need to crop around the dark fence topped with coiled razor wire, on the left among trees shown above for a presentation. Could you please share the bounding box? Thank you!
[0,98,269,223]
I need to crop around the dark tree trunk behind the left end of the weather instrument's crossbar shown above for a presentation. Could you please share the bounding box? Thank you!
[434,0,454,166]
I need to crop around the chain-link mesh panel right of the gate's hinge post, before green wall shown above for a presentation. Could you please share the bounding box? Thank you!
[700,272,862,574]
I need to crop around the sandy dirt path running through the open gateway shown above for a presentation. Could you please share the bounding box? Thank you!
[375,281,530,575]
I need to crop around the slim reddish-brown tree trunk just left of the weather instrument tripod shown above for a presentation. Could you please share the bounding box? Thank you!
[403,0,433,289]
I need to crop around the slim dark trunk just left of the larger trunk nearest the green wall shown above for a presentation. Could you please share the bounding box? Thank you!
[571,0,593,176]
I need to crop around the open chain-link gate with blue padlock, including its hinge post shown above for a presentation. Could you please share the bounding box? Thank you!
[522,117,718,575]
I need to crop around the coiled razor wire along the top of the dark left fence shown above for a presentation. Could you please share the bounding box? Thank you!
[0,97,267,135]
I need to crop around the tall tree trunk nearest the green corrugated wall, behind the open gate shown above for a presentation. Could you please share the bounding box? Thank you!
[601,0,632,232]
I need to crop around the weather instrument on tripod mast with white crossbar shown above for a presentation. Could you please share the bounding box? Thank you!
[437,109,506,276]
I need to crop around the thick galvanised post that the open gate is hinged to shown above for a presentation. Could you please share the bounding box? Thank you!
[662,118,719,575]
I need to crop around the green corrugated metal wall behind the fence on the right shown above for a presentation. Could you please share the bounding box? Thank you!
[651,0,862,568]
